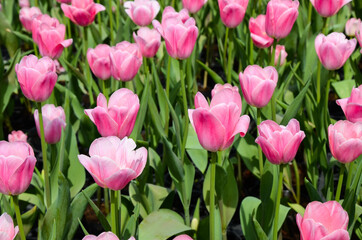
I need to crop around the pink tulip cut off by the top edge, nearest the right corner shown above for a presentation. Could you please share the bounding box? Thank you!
[310,0,352,17]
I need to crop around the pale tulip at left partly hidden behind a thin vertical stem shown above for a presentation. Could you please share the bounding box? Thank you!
[34,104,67,144]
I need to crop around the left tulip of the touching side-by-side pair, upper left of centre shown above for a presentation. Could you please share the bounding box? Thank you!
[87,44,112,80]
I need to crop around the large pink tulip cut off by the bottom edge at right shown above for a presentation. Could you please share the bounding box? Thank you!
[297,201,349,240]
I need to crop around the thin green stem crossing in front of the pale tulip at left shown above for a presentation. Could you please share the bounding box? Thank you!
[38,102,51,207]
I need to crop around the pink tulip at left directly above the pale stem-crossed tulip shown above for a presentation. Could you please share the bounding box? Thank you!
[15,55,58,102]
